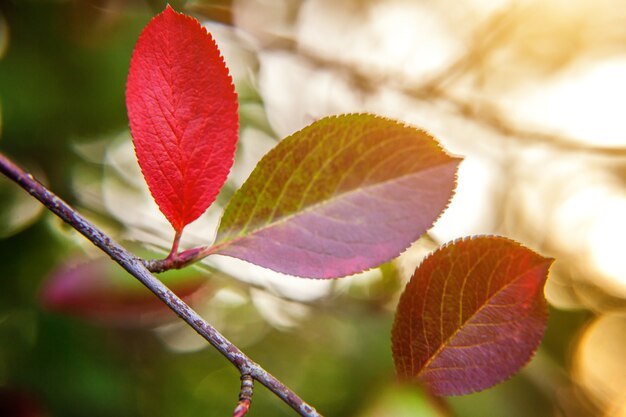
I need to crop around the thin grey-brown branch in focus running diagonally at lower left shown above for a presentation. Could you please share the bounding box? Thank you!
[0,153,322,417]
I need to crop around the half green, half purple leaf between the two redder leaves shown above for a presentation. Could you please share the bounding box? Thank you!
[215,114,460,278]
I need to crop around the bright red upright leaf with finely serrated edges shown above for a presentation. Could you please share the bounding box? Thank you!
[126,6,238,232]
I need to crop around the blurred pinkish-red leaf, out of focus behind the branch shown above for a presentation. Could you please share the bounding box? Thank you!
[40,259,206,326]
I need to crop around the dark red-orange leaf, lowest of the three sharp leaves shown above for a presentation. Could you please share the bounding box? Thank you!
[391,237,553,395]
